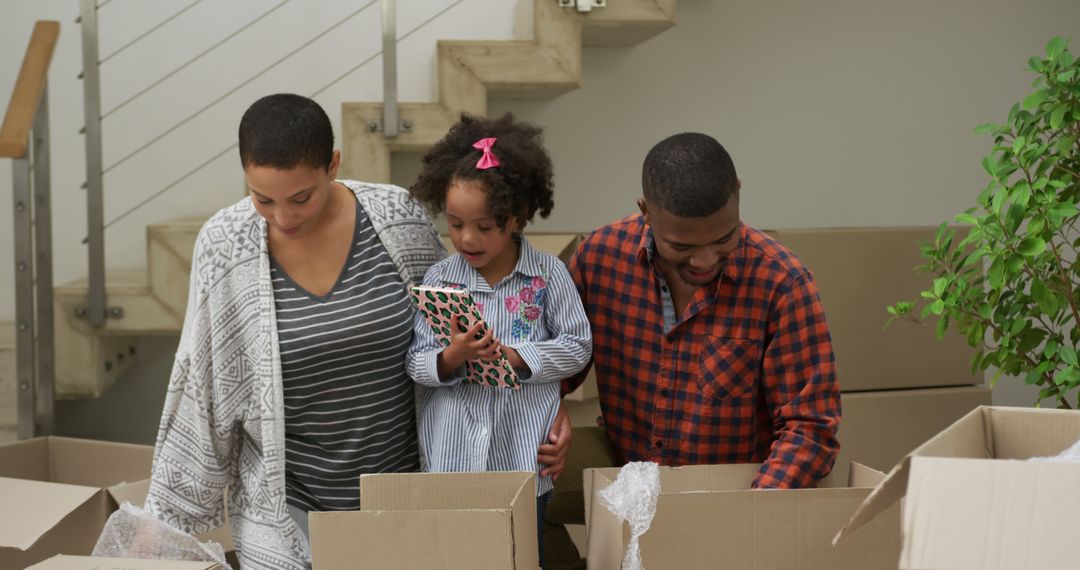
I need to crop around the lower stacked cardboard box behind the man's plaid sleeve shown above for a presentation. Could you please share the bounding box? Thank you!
[836,385,993,485]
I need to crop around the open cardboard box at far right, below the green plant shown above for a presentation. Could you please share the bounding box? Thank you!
[837,406,1080,570]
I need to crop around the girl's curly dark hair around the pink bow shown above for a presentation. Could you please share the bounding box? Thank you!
[409,113,555,229]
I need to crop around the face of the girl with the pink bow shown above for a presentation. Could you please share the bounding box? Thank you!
[444,179,521,270]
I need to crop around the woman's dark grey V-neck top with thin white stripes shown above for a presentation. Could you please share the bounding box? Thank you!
[270,197,419,511]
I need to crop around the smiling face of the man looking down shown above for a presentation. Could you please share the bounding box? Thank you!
[637,191,740,287]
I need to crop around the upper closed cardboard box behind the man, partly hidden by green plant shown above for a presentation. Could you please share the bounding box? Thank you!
[770,228,983,392]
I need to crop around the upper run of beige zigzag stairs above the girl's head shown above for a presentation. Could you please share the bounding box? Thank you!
[341,0,675,182]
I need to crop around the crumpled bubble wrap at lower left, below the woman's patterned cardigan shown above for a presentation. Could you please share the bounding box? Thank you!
[93,503,231,570]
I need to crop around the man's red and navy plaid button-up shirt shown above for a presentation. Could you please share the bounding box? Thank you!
[563,215,840,488]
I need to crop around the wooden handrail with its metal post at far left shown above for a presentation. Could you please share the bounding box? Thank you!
[0,22,60,438]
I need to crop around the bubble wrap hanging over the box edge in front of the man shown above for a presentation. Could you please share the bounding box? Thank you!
[597,461,660,570]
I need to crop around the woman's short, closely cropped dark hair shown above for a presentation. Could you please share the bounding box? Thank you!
[240,93,334,169]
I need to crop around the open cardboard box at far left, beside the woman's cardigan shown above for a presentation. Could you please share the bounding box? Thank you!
[0,437,153,568]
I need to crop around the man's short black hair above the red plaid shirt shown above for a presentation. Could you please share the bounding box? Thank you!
[642,133,739,218]
